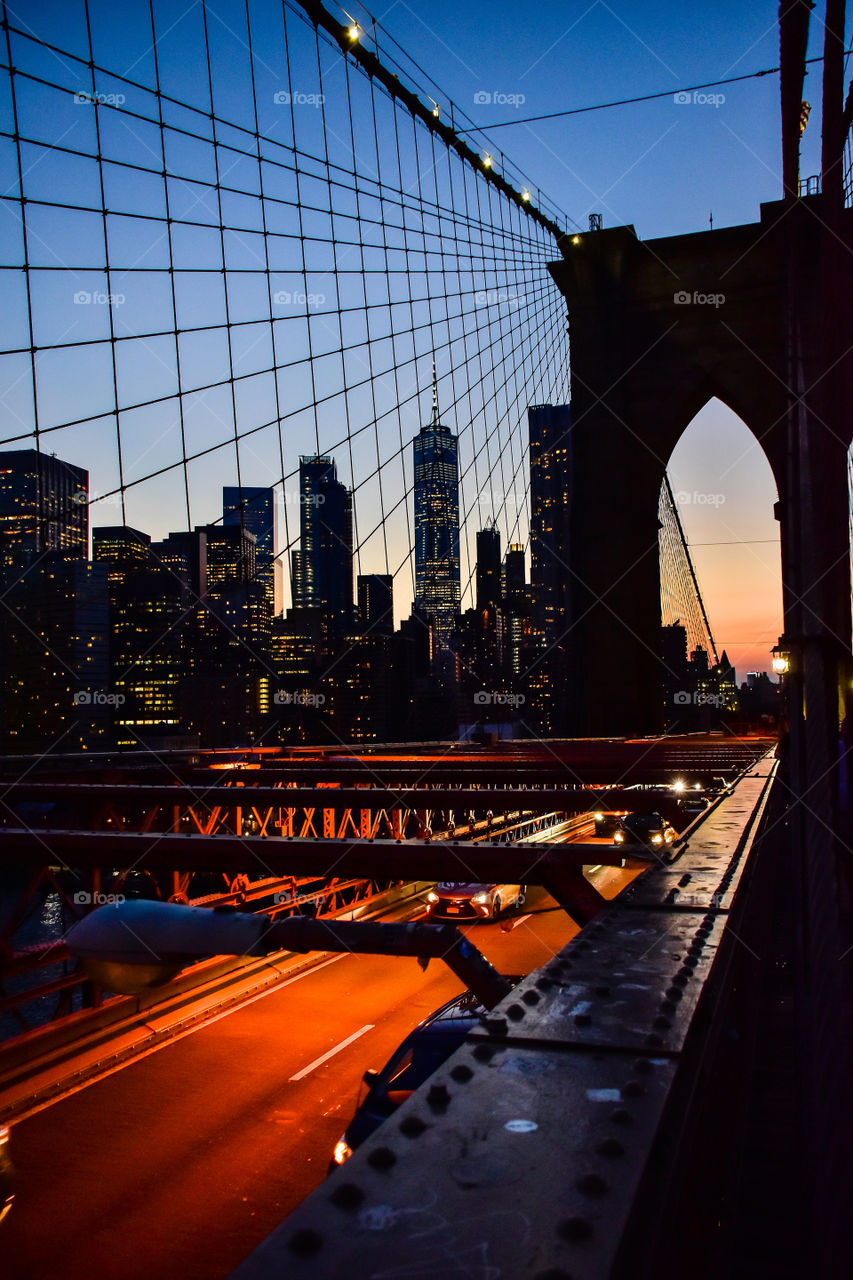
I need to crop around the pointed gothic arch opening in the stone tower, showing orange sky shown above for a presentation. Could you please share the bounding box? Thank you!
[661,397,783,731]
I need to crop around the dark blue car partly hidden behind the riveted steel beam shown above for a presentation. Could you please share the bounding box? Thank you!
[329,977,512,1172]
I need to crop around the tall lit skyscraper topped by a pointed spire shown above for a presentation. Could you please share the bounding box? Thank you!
[412,376,460,648]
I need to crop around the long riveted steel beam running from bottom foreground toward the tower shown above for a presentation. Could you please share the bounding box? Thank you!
[233,758,775,1280]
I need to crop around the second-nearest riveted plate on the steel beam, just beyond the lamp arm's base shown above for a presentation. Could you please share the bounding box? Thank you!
[473,909,725,1053]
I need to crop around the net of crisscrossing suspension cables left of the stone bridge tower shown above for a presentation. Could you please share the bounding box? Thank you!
[0,0,569,612]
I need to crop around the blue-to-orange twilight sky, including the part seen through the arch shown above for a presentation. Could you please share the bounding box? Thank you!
[0,0,849,678]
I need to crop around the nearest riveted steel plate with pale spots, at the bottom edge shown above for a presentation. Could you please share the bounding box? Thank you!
[232,1044,675,1280]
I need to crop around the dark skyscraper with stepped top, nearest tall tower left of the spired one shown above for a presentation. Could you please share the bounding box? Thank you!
[291,456,352,631]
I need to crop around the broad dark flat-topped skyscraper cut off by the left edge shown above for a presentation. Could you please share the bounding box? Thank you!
[0,449,88,567]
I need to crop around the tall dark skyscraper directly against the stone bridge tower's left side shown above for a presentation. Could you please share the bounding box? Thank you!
[528,404,571,643]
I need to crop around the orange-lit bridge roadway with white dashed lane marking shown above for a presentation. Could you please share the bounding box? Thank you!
[0,868,637,1280]
